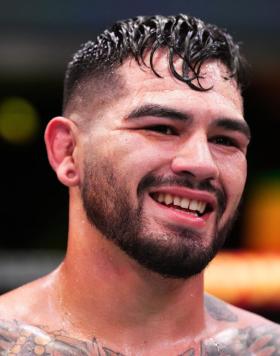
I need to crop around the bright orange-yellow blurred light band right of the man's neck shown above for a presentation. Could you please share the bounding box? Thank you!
[205,250,280,310]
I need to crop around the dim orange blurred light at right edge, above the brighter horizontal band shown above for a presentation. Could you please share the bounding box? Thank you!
[245,179,280,252]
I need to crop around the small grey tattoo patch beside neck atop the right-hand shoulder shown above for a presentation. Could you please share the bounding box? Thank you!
[204,295,238,322]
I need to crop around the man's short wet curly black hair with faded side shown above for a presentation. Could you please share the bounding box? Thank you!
[64,14,247,108]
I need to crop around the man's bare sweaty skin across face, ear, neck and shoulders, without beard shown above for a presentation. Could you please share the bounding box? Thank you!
[0,56,280,356]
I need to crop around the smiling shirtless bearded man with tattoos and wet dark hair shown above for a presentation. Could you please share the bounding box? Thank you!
[0,15,280,356]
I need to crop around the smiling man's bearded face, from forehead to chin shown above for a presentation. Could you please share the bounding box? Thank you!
[78,57,248,278]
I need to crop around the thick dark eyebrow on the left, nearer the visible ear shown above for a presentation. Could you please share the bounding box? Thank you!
[126,104,190,121]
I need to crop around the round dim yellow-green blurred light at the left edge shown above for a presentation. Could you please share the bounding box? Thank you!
[0,97,39,144]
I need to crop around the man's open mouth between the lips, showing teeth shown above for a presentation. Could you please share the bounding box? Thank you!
[150,192,214,217]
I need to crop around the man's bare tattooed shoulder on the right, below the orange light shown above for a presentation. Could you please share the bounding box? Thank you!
[201,295,280,356]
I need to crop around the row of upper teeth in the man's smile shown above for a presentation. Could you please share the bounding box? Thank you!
[155,193,207,214]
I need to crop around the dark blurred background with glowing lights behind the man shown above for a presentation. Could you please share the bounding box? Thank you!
[0,0,280,322]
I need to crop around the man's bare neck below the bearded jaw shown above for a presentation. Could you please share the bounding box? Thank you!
[53,192,204,348]
